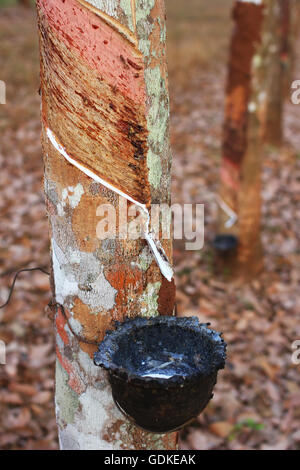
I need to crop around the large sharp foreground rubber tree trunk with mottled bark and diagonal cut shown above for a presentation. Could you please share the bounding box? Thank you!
[37,0,177,450]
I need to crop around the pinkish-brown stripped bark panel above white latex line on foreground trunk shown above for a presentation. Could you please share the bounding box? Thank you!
[40,0,150,203]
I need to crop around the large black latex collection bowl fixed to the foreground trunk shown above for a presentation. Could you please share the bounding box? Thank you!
[94,317,226,433]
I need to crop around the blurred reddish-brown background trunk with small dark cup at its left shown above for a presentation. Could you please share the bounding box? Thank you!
[218,0,265,279]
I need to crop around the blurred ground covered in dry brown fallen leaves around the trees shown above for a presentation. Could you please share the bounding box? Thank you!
[0,0,300,449]
